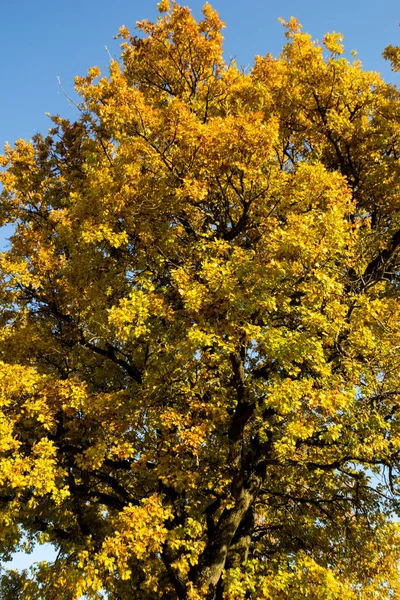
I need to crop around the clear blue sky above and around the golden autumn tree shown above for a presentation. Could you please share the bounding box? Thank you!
[0,0,400,567]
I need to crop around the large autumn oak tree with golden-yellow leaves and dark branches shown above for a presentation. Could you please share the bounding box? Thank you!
[0,1,400,600]
